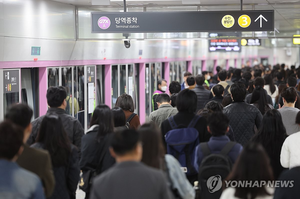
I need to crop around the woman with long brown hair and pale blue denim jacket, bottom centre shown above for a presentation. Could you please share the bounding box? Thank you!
[138,122,195,199]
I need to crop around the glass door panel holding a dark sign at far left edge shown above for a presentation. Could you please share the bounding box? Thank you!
[0,69,21,120]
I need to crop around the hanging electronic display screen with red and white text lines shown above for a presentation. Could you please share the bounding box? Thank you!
[209,33,241,52]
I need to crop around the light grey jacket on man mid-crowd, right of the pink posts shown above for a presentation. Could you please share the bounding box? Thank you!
[149,104,178,127]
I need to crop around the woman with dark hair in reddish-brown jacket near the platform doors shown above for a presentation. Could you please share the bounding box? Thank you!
[115,93,140,129]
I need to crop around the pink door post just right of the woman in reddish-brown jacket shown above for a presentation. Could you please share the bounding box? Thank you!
[139,63,146,124]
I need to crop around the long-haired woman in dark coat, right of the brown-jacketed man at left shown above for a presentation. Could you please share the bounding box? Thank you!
[31,114,79,199]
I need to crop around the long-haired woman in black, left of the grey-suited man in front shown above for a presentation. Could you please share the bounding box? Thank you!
[79,104,115,198]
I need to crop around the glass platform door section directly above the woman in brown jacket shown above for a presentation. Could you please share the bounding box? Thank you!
[112,64,139,113]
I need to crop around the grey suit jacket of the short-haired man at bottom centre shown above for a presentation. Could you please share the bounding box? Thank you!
[90,161,172,199]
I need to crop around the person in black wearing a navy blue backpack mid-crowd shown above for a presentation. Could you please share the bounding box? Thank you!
[161,89,210,184]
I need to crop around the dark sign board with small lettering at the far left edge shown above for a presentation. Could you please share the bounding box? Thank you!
[3,70,20,93]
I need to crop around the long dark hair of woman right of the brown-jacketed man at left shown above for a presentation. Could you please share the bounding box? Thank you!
[36,113,71,167]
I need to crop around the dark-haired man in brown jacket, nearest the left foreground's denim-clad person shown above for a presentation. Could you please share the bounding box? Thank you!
[5,104,55,198]
